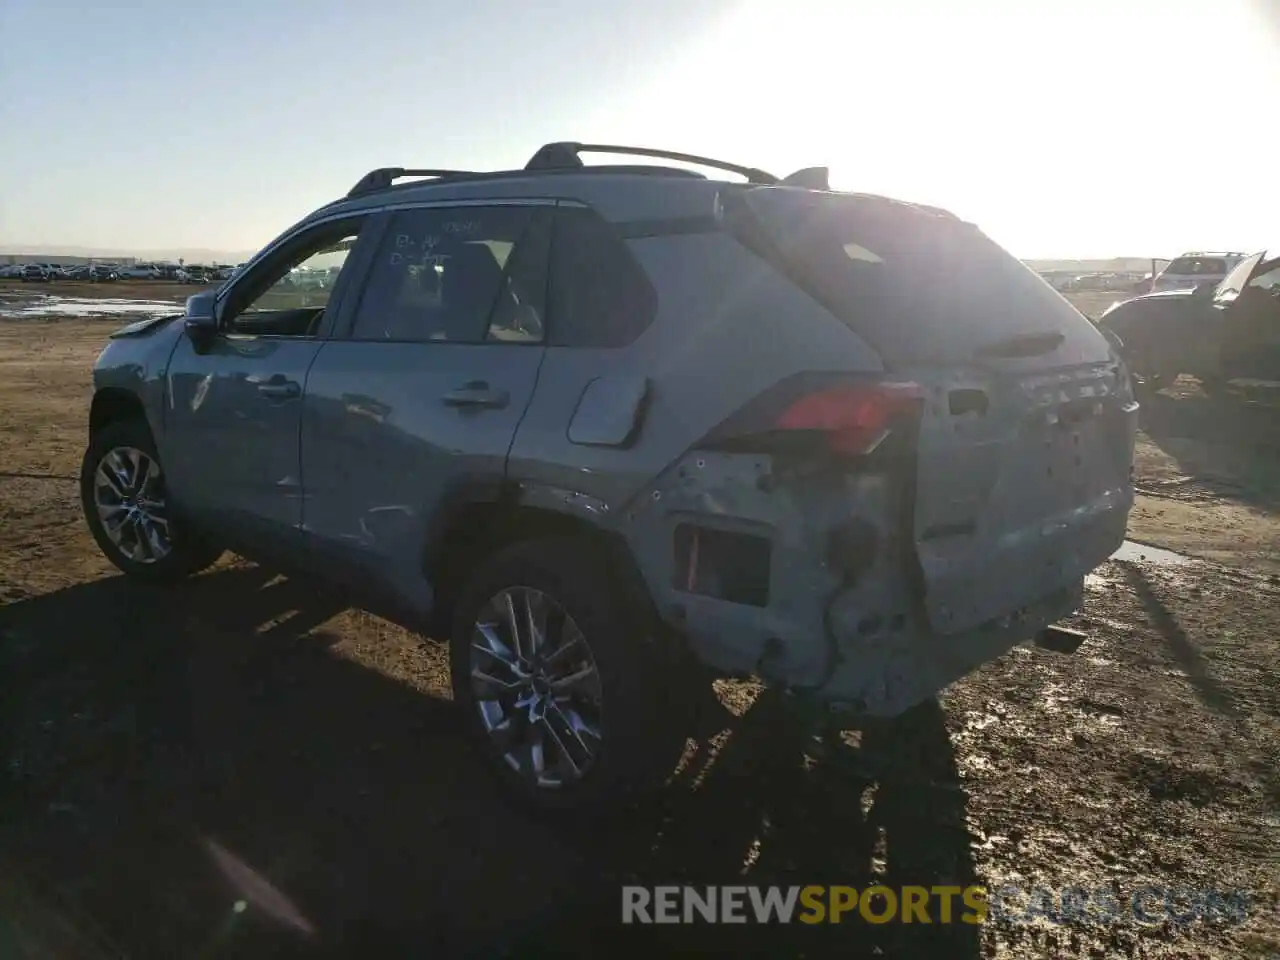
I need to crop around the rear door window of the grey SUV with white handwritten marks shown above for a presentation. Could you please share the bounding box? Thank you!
[352,206,550,343]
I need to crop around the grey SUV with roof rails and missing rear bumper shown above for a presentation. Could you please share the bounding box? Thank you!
[82,143,1137,808]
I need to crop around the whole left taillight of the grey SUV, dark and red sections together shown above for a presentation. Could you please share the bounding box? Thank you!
[708,375,924,457]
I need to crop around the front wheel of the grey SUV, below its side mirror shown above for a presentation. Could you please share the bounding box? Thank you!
[81,419,223,582]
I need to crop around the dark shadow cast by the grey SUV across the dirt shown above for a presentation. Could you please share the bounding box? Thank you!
[0,567,979,957]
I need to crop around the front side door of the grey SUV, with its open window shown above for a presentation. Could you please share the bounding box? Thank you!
[163,218,376,545]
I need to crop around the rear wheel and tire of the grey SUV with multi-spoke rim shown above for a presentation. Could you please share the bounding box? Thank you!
[449,539,690,814]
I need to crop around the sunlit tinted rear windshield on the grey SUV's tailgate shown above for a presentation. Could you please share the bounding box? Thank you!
[731,189,1101,364]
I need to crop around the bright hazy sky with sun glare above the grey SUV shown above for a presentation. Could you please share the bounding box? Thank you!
[0,0,1280,257]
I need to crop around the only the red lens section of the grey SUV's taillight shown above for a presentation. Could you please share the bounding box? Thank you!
[774,383,924,456]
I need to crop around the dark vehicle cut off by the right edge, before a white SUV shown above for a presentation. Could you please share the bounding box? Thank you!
[1098,247,1280,389]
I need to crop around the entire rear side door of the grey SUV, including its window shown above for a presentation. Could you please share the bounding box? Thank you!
[302,202,553,609]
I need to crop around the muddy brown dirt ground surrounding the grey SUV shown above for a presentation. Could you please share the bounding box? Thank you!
[0,296,1280,960]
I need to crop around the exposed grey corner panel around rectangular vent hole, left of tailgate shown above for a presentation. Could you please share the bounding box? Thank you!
[620,451,911,687]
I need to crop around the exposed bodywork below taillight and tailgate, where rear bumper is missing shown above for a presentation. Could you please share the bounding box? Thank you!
[614,452,1082,716]
